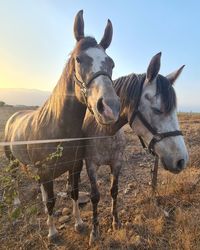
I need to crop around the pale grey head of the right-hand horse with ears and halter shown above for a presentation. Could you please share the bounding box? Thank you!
[132,53,188,173]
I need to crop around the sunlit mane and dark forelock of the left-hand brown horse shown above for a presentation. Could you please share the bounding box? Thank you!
[37,37,98,126]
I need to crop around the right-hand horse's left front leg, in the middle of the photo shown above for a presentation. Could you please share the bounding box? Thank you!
[86,161,100,246]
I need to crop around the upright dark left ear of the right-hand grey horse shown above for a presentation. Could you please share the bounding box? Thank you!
[146,52,161,82]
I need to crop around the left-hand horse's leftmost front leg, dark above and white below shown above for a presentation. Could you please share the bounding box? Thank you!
[41,181,58,239]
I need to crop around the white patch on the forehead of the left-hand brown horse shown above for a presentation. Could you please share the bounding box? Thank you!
[86,48,107,73]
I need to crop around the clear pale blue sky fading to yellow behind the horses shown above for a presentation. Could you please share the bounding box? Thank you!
[0,0,200,111]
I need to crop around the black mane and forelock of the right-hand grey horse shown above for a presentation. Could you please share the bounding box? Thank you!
[114,73,177,114]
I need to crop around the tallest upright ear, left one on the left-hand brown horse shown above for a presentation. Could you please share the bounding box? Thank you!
[74,10,84,42]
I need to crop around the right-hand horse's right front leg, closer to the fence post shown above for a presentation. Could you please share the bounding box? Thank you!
[110,161,121,230]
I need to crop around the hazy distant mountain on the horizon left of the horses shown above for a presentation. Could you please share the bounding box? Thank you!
[0,88,50,106]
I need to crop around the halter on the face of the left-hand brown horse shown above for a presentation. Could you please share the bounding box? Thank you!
[73,70,113,114]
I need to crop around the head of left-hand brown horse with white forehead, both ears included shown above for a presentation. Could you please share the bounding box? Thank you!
[71,11,120,124]
